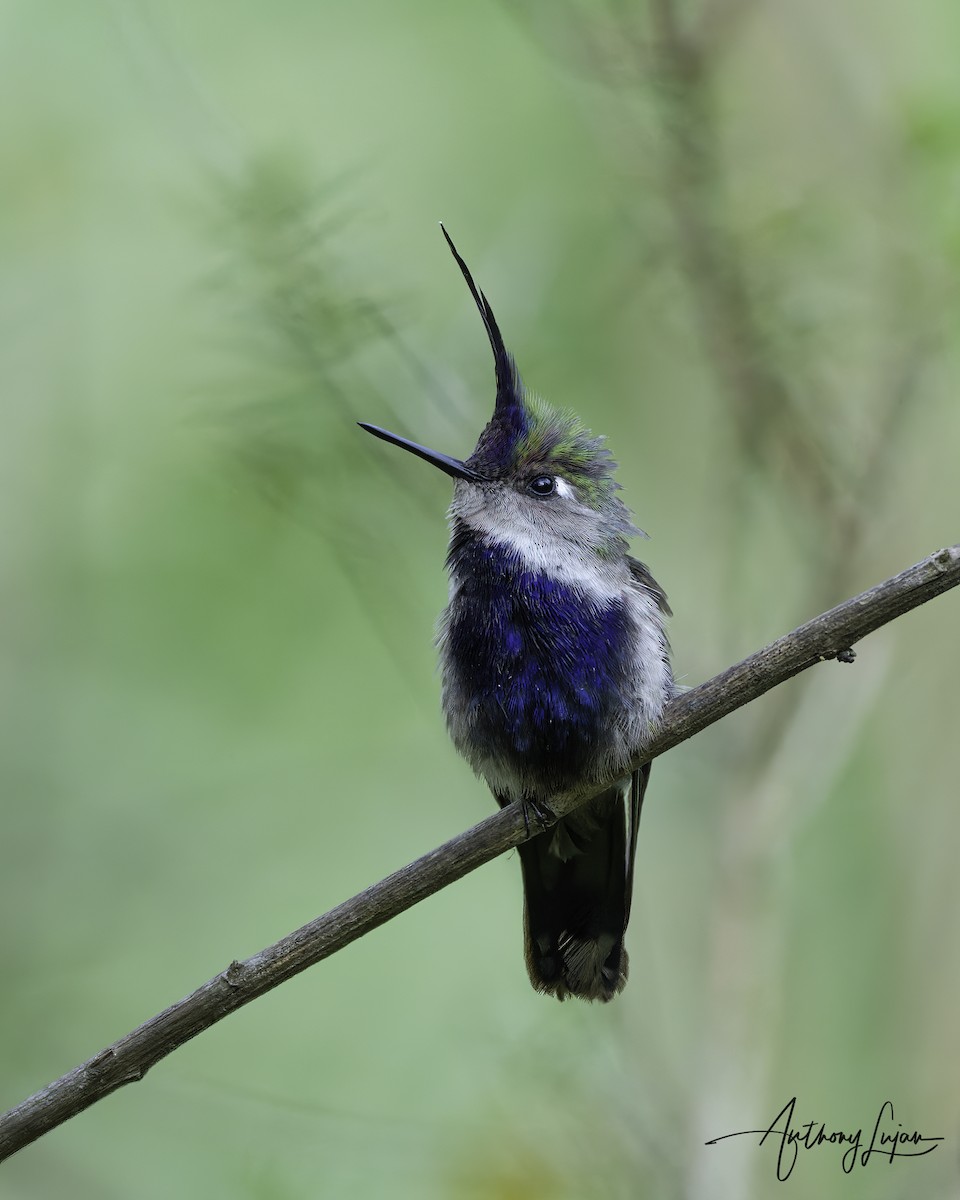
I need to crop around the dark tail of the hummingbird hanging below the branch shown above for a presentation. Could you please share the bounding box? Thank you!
[518,763,650,1001]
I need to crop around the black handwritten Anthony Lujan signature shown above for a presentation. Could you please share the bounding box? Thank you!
[707,1096,943,1181]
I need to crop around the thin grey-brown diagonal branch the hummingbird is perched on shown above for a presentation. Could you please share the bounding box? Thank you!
[0,545,960,1162]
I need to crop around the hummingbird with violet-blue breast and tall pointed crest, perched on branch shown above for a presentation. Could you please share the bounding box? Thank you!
[360,226,674,1001]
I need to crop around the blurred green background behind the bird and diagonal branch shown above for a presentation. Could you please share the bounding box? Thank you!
[0,0,960,1200]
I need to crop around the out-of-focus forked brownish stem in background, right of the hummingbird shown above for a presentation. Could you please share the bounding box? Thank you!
[640,0,912,1200]
